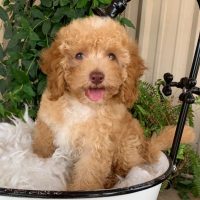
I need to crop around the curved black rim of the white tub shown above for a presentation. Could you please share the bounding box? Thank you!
[0,156,173,199]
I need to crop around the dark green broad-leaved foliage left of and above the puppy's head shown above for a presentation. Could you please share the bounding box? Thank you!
[0,0,114,119]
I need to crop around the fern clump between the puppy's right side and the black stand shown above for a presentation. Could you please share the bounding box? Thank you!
[131,81,187,137]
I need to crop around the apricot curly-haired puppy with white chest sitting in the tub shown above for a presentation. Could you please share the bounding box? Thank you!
[33,16,193,190]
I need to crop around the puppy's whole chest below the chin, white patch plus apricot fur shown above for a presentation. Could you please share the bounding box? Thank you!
[43,98,125,154]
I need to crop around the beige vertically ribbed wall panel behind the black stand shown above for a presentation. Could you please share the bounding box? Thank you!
[126,0,200,152]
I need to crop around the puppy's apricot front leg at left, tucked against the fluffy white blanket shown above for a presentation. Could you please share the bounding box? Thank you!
[32,120,55,158]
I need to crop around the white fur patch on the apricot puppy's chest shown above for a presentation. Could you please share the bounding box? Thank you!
[53,101,96,149]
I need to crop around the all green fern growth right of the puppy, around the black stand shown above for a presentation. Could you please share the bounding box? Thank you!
[130,80,200,200]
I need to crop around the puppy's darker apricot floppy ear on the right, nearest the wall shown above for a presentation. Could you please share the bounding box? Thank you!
[121,44,146,108]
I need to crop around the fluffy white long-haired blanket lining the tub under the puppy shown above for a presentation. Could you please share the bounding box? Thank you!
[0,111,169,191]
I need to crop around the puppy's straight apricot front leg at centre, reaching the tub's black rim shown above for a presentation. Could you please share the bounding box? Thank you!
[68,149,112,191]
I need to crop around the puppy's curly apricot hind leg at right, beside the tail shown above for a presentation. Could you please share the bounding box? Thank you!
[114,118,148,177]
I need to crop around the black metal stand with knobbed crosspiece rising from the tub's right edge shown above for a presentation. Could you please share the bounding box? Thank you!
[163,36,200,165]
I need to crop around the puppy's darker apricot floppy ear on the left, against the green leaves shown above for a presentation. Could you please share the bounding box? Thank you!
[40,41,65,100]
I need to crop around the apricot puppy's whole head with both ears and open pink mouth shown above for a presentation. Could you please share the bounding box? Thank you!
[41,17,144,106]
